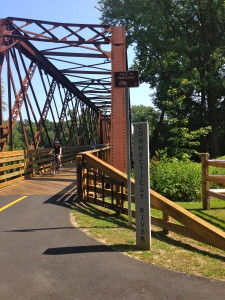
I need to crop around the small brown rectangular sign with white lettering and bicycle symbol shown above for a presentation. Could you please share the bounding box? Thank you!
[114,70,139,88]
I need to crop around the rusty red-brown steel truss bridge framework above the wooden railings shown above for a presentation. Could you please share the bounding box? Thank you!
[0,17,127,170]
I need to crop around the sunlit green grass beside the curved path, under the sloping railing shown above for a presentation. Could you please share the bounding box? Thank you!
[73,200,225,280]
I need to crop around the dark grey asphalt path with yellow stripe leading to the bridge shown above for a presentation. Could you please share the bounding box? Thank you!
[0,170,225,300]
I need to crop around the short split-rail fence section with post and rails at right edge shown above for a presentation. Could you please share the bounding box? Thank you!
[201,153,225,209]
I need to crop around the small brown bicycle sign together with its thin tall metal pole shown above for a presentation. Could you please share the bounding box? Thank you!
[114,70,139,226]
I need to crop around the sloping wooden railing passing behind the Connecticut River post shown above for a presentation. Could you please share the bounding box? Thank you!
[76,149,225,250]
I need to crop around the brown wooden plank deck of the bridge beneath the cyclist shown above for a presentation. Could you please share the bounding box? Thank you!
[0,165,76,196]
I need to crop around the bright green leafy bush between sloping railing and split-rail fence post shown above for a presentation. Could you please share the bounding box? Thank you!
[150,157,202,202]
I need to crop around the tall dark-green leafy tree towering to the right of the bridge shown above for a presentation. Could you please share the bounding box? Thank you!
[99,0,225,156]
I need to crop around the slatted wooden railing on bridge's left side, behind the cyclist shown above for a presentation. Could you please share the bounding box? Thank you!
[0,146,90,188]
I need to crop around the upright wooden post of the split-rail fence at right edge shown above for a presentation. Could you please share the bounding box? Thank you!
[201,153,210,210]
